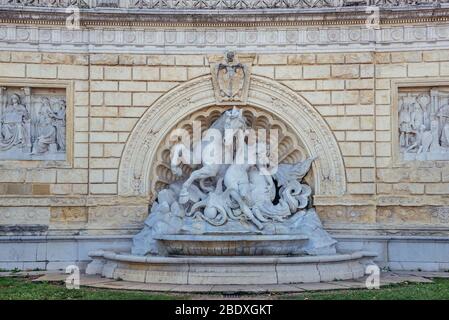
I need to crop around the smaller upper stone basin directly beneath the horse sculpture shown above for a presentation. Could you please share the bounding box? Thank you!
[151,234,308,256]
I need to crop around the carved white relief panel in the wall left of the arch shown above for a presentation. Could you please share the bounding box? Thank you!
[0,85,67,160]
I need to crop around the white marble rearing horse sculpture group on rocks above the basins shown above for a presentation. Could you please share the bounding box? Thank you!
[132,108,336,255]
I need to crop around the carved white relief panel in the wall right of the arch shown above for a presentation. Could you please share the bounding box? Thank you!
[397,86,449,161]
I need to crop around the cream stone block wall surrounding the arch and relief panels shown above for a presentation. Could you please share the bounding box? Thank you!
[0,50,449,238]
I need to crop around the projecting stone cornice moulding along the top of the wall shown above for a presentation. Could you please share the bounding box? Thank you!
[0,0,449,28]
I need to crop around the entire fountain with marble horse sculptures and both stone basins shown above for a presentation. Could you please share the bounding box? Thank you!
[86,107,373,284]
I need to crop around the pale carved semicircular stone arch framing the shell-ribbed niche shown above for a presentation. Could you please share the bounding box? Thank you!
[118,75,346,200]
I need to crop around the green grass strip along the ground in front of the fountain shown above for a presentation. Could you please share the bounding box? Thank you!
[0,277,449,300]
